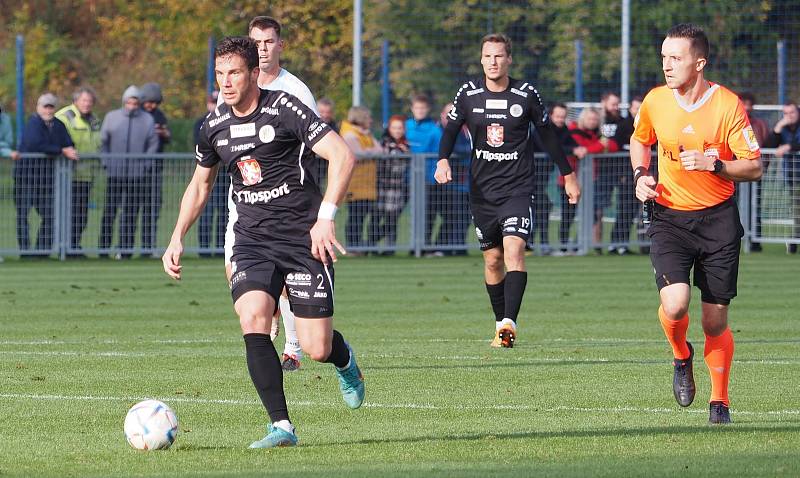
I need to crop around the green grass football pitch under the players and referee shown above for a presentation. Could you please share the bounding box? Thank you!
[0,252,800,478]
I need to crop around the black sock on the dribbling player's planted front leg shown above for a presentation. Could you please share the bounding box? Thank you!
[244,334,289,423]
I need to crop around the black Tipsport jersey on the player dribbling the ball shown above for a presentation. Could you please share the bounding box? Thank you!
[195,90,331,245]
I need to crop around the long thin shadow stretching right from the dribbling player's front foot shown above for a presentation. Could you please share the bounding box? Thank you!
[303,421,800,448]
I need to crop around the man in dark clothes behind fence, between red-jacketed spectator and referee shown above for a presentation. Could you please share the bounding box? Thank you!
[595,92,639,256]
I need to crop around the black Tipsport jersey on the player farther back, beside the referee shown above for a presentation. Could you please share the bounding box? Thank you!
[445,78,549,201]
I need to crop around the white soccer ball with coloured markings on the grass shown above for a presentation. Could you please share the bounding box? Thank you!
[124,400,178,450]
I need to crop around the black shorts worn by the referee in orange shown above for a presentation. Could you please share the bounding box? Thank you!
[647,199,744,305]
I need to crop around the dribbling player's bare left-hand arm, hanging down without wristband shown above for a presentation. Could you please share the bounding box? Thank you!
[161,165,219,280]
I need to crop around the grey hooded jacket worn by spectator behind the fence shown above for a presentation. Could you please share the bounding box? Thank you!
[100,108,158,178]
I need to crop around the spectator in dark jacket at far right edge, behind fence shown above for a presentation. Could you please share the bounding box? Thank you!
[768,102,800,254]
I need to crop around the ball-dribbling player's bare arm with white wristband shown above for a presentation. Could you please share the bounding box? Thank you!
[311,131,356,264]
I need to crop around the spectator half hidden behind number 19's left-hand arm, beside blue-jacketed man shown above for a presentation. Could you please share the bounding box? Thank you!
[436,103,472,256]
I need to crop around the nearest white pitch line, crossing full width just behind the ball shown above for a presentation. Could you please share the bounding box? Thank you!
[0,393,800,416]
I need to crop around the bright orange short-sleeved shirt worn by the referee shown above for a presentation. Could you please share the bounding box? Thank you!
[632,82,761,211]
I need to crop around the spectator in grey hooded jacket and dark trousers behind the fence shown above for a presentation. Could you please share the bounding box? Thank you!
[99,85,158,258]
